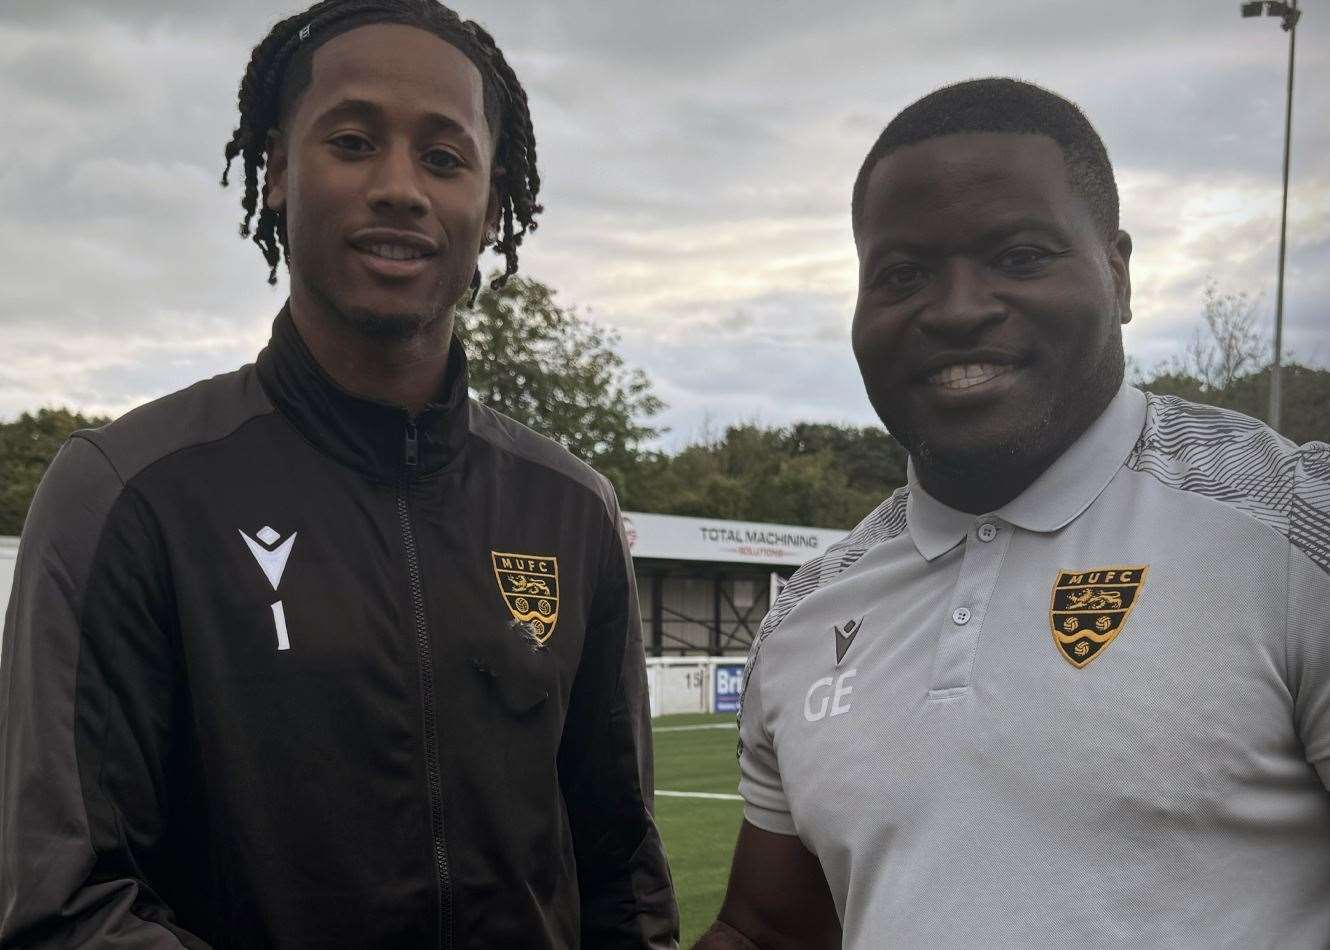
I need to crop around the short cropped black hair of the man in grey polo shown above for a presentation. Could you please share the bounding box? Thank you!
[850,77,1119,242]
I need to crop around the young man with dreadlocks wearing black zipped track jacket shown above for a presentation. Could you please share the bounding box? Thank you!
[0,0,677,949]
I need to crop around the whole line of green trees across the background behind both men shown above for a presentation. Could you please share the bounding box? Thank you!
[0,277,1330,535]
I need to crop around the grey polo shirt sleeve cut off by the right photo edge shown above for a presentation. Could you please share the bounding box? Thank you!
[1287,443,1330,790]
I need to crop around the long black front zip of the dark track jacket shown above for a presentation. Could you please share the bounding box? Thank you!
[398,419,452,947]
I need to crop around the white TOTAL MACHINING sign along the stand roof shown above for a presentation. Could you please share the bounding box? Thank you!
[624,511,847,567]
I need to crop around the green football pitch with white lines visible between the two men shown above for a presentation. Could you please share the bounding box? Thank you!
[652,713,743,947]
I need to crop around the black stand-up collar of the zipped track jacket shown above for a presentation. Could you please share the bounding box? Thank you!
[257,303,471,482]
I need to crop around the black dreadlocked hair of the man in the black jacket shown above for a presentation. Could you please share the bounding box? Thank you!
[222,0,544,303]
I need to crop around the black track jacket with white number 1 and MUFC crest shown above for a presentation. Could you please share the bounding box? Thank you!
[0,310,678,949]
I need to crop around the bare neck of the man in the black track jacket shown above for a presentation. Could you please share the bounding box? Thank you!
[290,287,454,415]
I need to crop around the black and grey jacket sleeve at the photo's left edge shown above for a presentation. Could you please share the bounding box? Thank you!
[0,436,206,949]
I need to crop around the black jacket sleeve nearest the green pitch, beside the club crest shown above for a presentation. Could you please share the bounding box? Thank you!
[559,496,678,949]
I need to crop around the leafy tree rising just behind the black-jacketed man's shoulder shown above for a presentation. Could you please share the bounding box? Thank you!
[458,270,665,492]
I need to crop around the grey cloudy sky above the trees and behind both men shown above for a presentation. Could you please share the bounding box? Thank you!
[0,0,1330,446]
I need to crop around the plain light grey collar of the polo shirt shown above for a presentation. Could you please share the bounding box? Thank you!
[906,382,1145,560]
